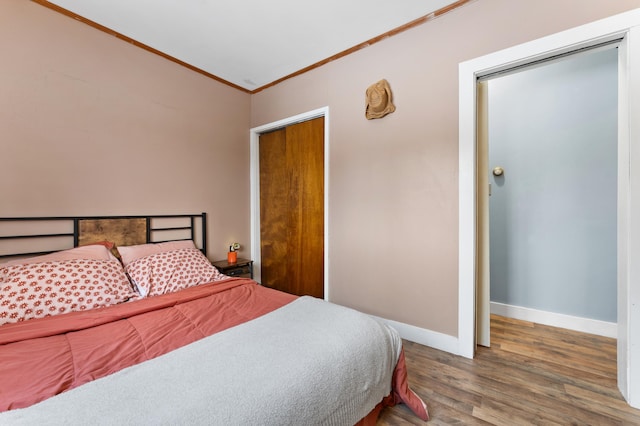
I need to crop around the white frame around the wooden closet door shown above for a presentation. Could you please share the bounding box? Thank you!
[249,106,329,300]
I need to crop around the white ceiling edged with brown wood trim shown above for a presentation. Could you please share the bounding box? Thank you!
[47,0,464,92]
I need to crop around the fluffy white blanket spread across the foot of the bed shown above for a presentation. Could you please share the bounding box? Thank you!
[0,297,401,425]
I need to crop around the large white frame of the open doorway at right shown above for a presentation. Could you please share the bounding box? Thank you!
[458,9,640,408]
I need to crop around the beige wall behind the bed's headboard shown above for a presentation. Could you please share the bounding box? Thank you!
[0,0,250,259]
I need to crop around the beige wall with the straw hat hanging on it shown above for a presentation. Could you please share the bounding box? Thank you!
[251,0,640,336]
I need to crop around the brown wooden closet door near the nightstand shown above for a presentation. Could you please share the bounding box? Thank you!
[259,117,324,297]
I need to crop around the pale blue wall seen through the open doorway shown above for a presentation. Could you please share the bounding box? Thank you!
[488,48,618,322]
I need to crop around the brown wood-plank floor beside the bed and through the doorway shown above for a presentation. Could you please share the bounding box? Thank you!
[378,315,640,426]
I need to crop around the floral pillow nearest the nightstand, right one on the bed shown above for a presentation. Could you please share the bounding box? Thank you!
[125,248,228,297]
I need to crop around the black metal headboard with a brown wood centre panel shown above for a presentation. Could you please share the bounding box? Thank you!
[0,212,207,258]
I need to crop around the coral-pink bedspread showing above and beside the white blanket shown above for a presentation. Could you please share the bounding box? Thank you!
[0,278,427,420]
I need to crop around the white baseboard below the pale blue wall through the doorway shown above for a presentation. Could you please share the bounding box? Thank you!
[490,302,618,339]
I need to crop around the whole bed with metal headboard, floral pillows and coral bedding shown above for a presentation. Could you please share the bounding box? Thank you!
[0,213,428,425]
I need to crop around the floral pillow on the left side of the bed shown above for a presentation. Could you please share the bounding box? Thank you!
[0,259,138,325]
